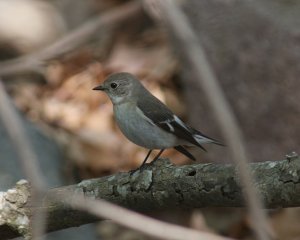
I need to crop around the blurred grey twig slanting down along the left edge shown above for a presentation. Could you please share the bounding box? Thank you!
[0,79,46,239]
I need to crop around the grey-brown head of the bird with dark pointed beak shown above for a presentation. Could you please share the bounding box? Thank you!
[93,72,140,104]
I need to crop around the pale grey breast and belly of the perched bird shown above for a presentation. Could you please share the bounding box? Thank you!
[114,103,177,149]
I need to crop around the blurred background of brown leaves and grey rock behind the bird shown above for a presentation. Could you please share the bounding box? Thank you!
[0,0,300,240]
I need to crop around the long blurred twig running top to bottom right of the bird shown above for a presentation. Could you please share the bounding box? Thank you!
[146,0,271,240]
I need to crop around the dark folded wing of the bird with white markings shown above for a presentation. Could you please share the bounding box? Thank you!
[137,96,205,150]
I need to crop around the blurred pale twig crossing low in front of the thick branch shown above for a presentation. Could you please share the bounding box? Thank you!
[58,194,233,240]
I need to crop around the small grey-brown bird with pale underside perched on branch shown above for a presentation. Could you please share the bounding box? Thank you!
[93,72,223,167]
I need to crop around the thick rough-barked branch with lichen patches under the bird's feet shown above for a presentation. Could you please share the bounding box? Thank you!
[0,154,300,239]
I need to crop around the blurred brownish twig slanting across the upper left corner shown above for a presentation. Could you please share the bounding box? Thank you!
[0,1,141,76]
